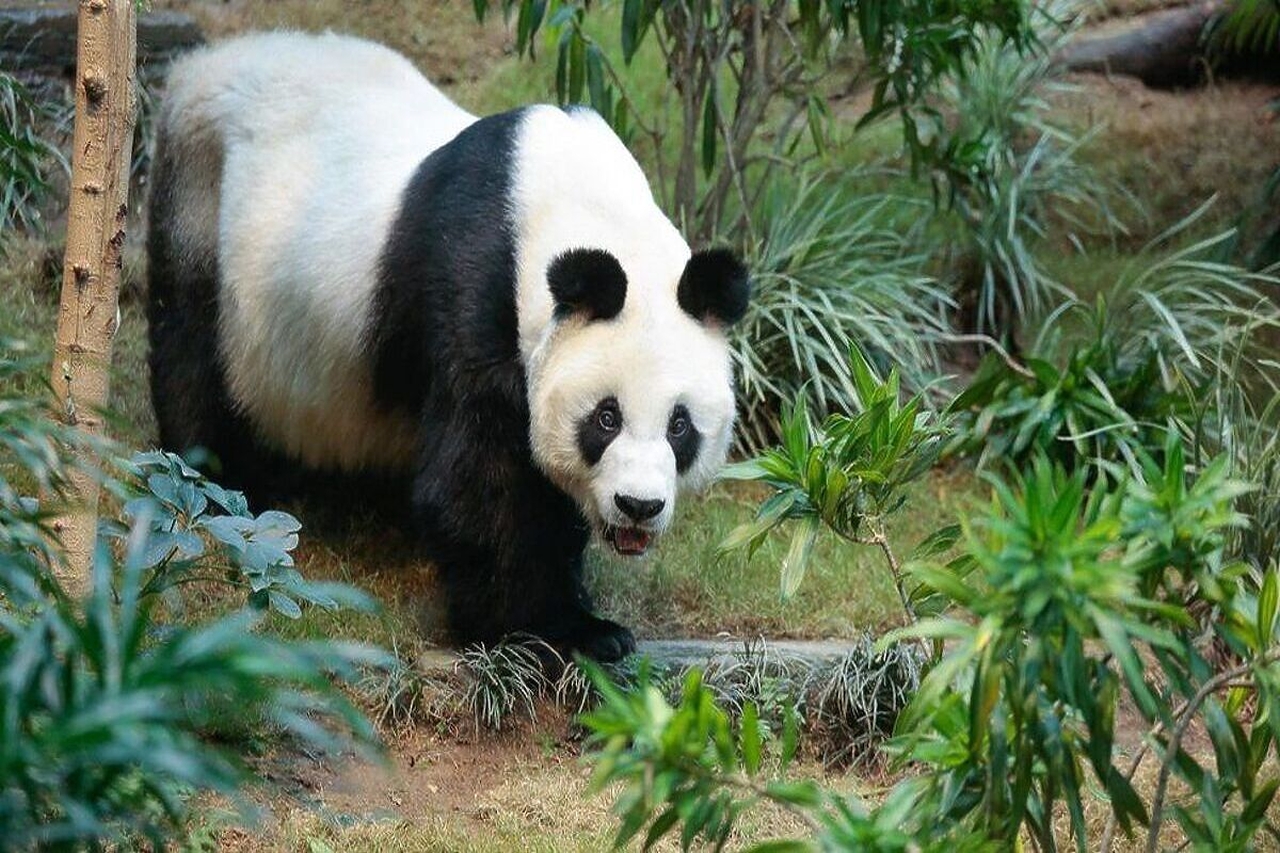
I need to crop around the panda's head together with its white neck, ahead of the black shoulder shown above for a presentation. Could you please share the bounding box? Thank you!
[512,108,749,555]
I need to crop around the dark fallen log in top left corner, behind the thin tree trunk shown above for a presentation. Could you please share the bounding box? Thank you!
[0,4,205,76]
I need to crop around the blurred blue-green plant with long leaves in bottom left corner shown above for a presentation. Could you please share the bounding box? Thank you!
[0,540,378,849]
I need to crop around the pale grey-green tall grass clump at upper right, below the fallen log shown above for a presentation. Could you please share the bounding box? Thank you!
[943,13,1138,337]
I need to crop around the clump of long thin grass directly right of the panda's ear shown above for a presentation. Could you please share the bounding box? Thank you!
[733,175,950,452]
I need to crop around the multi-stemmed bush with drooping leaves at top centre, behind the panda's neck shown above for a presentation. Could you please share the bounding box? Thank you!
[475,0,1034,242]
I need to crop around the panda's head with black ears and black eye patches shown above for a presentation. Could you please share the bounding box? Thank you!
[529,241,750,555]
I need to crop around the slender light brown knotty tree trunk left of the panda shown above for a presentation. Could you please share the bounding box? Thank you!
[51,0,136,596]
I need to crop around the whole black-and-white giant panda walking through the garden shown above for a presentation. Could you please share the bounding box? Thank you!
[148,33,748,658]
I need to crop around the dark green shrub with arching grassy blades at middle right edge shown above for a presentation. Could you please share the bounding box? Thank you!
[950,216,1280,469]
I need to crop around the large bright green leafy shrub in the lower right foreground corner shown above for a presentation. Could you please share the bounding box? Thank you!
[897,433,1280,849]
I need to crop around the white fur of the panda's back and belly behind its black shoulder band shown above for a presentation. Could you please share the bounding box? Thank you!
[161,33,475,470]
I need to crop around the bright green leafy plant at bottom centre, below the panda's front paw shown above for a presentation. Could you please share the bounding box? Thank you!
[582,662,993,853]
